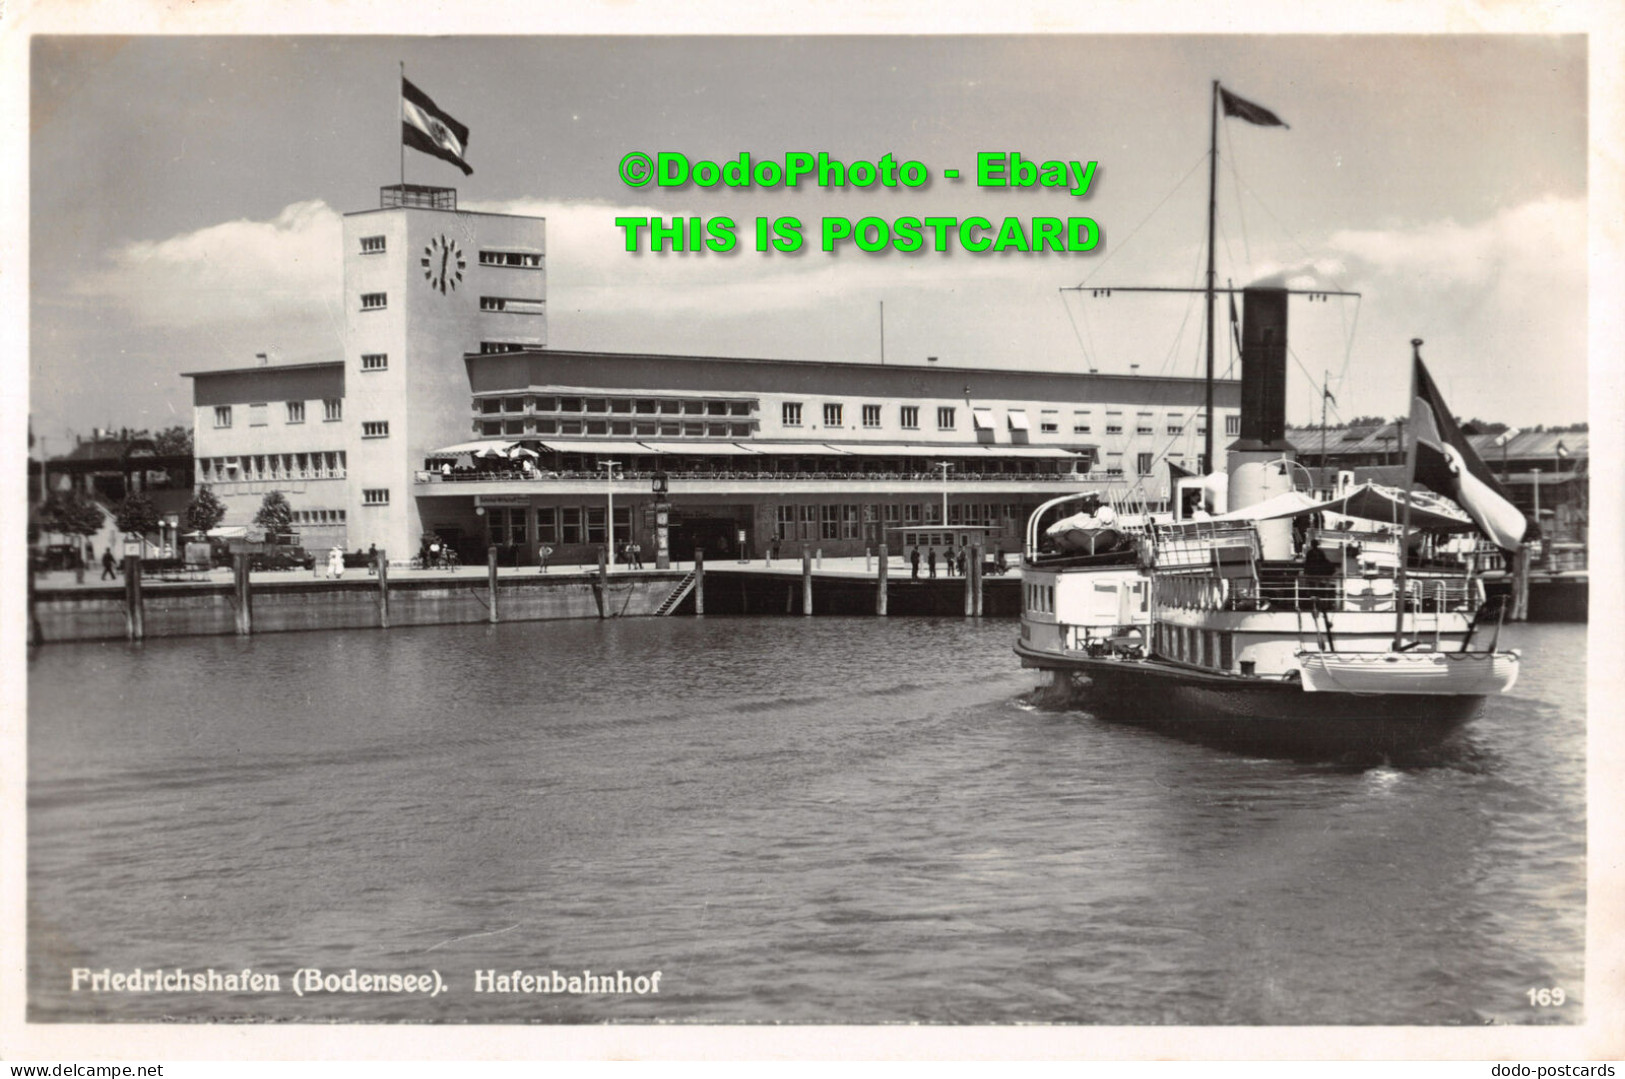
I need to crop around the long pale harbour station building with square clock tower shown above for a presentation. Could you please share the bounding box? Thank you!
[187,184,1240,566]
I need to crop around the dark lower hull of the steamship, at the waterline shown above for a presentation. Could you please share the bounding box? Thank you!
[1016,645,1484,759]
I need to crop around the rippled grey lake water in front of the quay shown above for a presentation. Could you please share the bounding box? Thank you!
[28,618,1586,1024]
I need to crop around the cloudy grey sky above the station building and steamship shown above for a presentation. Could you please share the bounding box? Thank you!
[29,34,1588,449]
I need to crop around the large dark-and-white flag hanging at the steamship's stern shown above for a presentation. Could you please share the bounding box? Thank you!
[1411,356,1532,551]
